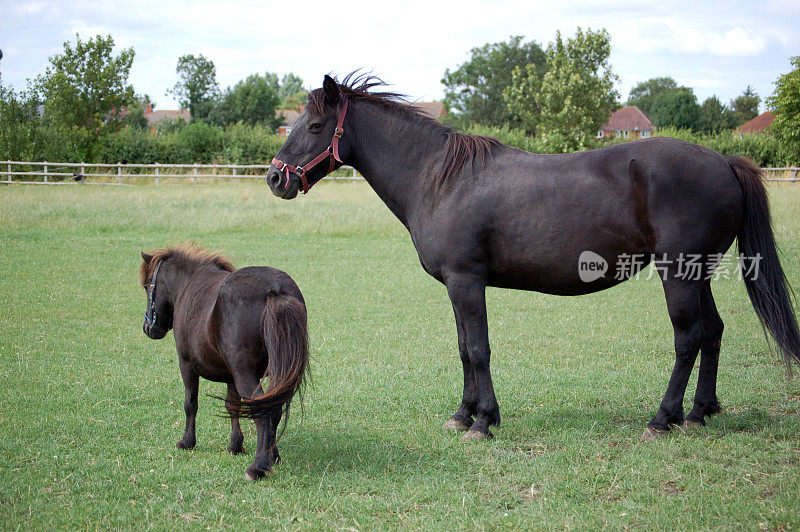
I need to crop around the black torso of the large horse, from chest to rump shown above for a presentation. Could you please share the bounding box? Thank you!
[412,138,742,294]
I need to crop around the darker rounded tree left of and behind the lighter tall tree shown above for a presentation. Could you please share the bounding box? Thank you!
[442,35,546,126]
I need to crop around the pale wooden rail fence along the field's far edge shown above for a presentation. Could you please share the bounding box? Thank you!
[0,161,800,186]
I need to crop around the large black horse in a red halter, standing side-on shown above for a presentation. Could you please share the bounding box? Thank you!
[266,74,800,439]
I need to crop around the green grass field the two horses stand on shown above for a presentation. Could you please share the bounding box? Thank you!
[0,183,800,530]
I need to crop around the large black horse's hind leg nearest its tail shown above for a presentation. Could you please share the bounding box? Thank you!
[686,281,725,425]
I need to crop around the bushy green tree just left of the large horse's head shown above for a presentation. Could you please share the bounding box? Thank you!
[209,72,283,129]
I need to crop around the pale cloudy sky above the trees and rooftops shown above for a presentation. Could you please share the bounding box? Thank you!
[0,0,800,109]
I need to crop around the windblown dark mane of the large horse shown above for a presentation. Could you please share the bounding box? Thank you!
[308,71,500,187]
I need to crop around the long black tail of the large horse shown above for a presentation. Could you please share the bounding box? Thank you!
[727,157,800,375]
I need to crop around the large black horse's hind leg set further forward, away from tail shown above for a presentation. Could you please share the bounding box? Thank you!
[642,278,703,439]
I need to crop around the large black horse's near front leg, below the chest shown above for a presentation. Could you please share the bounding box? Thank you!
[446,274,500,440]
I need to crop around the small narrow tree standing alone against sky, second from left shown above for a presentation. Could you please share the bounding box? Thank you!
[167,55,219,120]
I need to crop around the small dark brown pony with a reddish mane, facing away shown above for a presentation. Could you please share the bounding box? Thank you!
[139,245,308,480]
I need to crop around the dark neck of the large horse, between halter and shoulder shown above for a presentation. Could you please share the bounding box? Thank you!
[345,102,446,226]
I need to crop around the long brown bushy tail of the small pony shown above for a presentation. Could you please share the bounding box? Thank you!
[239,294,308,427]
